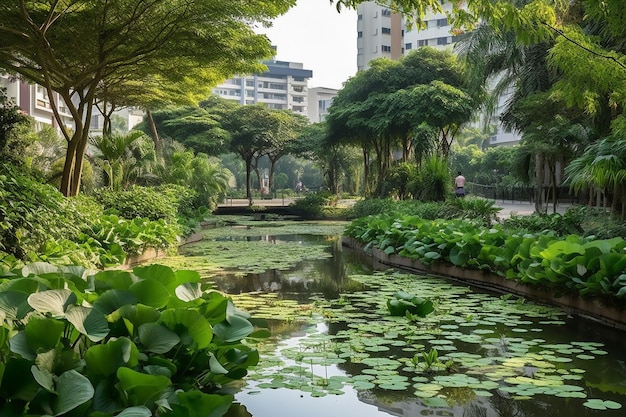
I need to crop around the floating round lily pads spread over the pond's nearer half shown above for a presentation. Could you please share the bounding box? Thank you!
[235,271,621,409]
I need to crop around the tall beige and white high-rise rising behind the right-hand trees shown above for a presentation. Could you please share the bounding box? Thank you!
[357,1,520,146]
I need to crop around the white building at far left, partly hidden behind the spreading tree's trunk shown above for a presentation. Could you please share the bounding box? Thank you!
[0,74,74,130]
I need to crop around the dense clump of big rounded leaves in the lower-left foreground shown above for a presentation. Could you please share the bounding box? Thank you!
[0,263,262,417]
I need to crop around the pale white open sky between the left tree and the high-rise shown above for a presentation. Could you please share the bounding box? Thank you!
[257,0,357,89]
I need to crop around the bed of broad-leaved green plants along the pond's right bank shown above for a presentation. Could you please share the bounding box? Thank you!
[345,215,626,301]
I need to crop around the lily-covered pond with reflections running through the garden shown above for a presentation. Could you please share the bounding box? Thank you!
[159,219,626,417]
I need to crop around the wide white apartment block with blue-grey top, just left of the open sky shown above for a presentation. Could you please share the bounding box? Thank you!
[213,60,313,116]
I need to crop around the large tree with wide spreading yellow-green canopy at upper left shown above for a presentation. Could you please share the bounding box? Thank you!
[0,0,293,195]
